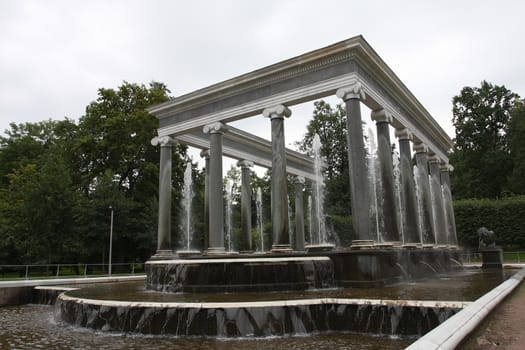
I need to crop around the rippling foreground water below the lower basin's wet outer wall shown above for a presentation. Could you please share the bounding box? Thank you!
[0,305,414,350]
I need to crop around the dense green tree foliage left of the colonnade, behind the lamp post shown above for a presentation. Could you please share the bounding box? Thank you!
[0,82,186,263]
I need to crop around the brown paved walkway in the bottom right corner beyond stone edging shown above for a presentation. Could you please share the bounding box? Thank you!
[458,274,525,350]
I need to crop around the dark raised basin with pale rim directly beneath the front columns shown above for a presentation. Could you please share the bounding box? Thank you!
[146,256,335,293]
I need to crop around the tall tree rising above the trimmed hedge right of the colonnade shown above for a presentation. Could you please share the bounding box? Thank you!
[450,81,519,198]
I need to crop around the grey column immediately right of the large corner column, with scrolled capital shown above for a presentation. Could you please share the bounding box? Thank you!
[372,109,401,242]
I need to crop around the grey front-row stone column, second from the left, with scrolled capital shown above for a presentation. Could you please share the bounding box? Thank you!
[203,123,226,255]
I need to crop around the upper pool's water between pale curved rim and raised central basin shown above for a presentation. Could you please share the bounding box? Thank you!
[68,269,515,302]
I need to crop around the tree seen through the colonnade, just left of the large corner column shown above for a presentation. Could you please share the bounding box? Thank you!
[297,100,350,216]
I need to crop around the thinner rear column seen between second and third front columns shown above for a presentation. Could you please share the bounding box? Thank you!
[237,160,253,253]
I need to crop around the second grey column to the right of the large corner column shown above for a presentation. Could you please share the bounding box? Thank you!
[396,128,421,244]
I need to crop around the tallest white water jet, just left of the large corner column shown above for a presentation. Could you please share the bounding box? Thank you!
[312,134,327,244]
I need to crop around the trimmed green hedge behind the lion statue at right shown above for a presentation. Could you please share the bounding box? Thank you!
[454,196,525,249]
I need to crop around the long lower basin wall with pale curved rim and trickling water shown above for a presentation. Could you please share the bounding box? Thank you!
[57,292,462,337]
